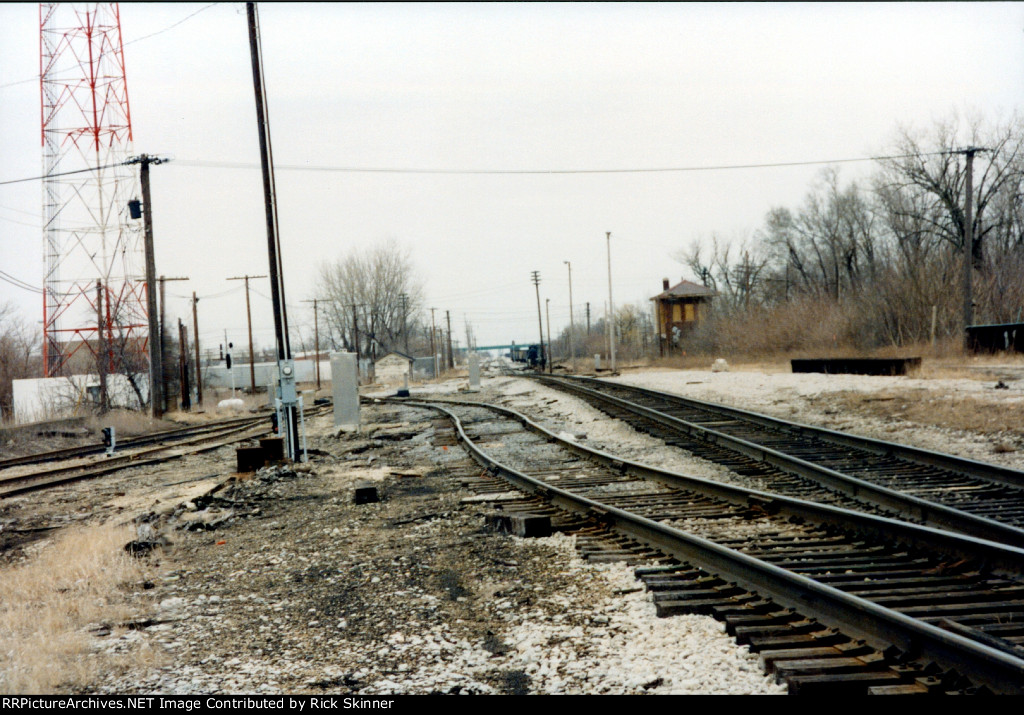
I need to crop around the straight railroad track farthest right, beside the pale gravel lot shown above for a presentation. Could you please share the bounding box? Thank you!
[536,376,1024,546]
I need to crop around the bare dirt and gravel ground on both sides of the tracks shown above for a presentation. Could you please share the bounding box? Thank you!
[6,358,1022,695]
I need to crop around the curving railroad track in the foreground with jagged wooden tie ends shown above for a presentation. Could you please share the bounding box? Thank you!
[396,401,1024,693]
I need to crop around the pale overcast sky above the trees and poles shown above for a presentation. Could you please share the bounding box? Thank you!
[0,2,1024,349]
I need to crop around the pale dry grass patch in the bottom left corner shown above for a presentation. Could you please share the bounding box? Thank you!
[0,527,157,693]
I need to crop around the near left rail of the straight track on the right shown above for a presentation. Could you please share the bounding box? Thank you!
[537,370,1024,545]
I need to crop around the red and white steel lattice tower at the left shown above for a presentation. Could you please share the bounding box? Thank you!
[39,3,147,377]
